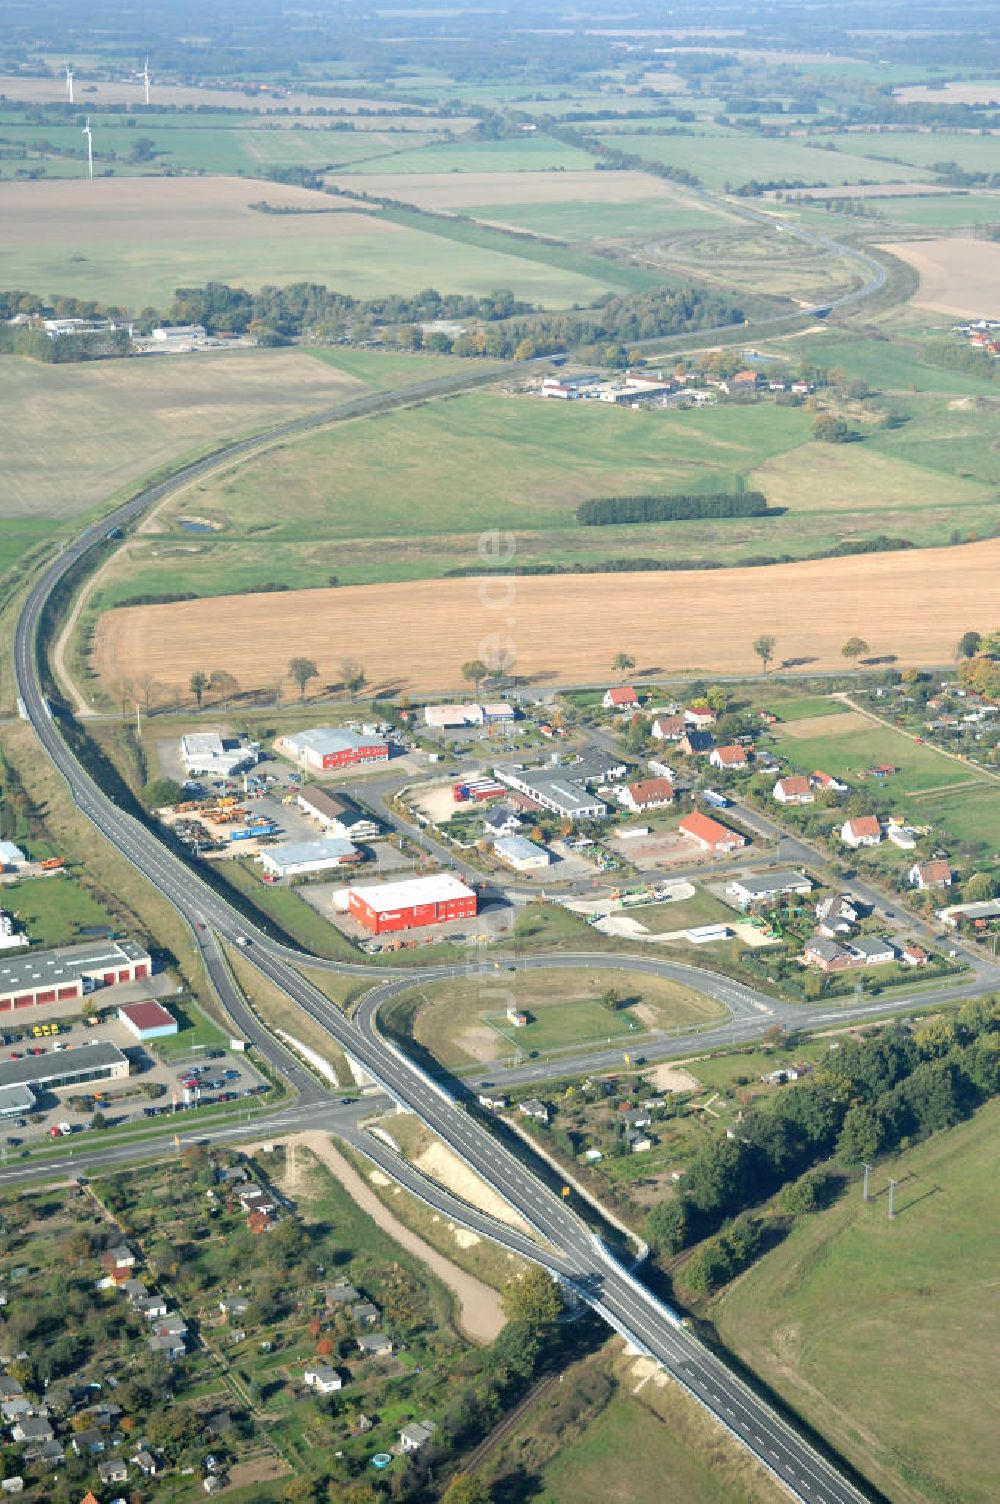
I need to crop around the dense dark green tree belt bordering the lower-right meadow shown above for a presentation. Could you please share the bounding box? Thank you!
[648,997,1000,1254]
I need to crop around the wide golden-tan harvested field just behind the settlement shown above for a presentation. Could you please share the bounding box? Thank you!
[95,540,1000,692]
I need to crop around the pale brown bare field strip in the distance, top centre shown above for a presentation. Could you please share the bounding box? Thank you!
[326,168,682,209]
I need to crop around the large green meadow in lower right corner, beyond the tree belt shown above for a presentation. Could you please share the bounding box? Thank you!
[714,1102,1000,1504]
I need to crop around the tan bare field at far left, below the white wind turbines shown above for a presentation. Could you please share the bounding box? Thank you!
[0,177,376,255]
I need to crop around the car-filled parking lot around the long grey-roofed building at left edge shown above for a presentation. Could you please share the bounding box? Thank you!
[0,1010,268,1158]
